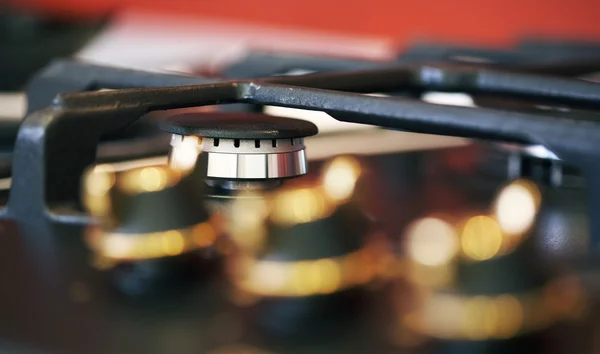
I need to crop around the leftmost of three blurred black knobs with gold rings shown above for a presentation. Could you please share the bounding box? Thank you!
[85,159,220,296]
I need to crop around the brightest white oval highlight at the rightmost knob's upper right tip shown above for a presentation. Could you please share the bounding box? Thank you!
[495,180,541,239]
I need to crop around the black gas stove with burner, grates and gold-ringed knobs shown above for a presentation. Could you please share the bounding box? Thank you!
[0,41,600,353]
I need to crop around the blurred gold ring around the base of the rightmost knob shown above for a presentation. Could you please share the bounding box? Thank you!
[403,279,583,340]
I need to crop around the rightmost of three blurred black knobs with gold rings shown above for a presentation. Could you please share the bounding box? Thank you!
[398,180,584,353]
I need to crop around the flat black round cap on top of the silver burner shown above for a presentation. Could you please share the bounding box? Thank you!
[158,112,318,139]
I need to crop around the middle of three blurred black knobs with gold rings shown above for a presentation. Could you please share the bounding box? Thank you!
[230,157,387,335]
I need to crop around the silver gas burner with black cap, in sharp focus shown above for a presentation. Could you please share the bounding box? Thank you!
[159,112,318,189]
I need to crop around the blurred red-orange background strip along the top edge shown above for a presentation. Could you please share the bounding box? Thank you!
[14,0,600,45]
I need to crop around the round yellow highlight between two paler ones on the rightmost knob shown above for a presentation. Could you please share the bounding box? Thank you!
[461,215,502,261]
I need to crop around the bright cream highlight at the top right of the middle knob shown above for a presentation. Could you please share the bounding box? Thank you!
[322,156,361,202]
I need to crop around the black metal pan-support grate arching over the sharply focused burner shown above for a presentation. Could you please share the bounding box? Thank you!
[3,61,600,243]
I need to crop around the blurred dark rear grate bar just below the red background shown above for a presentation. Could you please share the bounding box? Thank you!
[222,39,600,79]
